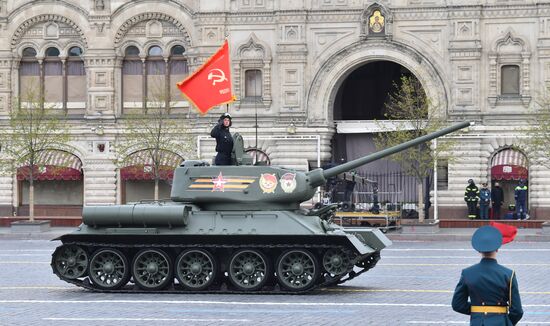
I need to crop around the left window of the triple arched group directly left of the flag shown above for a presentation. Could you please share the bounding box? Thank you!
[122,46,145,112]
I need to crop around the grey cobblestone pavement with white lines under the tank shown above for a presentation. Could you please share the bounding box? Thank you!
[0,240,550,326]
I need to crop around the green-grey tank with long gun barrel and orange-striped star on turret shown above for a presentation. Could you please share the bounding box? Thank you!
[51,122,469,293]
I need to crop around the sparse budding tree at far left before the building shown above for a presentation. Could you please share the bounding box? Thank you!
[0,86,69,221]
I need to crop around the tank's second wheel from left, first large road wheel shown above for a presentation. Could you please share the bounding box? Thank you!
[88,249,130,290]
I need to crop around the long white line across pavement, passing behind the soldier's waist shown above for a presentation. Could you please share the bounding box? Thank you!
[0,300,550,309]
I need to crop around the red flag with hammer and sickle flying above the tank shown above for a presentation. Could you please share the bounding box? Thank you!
[177,40,235,114]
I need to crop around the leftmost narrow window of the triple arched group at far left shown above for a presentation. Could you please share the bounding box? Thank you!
[19,48,40,98]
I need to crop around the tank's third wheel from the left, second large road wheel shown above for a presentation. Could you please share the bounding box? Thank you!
[132,249,174,291]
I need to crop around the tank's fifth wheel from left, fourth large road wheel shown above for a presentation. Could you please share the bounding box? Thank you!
[229,249,272,291]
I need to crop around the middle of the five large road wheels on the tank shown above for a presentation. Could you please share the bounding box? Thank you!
[176,249,218,291]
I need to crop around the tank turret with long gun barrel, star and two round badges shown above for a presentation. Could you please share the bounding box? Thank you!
[171,122,469,210]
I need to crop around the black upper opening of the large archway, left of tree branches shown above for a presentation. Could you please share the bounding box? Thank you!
[334,61,413,120]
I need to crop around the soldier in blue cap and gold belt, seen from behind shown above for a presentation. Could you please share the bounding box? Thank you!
[452,226,523,326]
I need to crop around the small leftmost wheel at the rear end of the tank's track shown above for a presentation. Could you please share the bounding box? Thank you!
[51,245,88,280]
